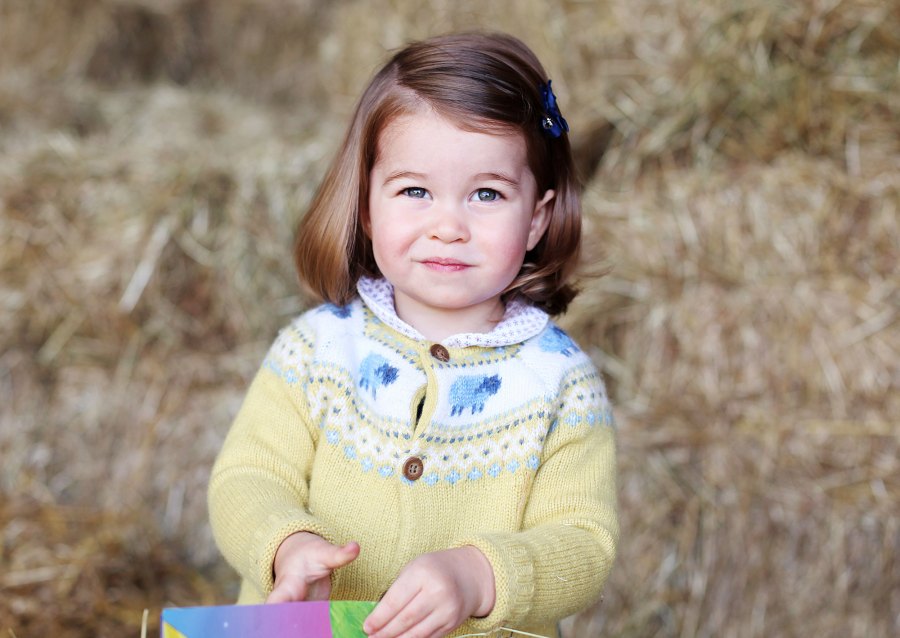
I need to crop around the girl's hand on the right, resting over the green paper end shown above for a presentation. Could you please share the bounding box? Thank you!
[363,546,495,638]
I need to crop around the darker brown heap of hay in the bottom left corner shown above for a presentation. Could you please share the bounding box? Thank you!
[0,499,222,638]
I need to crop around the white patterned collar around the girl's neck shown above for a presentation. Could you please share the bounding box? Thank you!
[356,277,549,348]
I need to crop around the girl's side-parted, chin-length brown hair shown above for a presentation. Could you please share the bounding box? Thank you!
[294,33,581,314]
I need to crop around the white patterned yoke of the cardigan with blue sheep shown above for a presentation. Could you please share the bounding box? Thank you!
[264,300,612,486]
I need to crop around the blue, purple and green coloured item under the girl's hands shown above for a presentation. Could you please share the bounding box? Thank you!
[160,600,375,638]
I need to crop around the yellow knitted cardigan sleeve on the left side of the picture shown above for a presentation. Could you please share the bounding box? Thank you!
[208,344,334,597]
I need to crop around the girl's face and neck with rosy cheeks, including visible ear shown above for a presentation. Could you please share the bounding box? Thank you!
[364,108,555,341]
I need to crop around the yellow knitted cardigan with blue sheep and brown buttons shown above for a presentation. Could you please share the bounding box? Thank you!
[209,279,618,636]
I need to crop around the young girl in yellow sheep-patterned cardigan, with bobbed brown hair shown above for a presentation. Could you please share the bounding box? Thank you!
[209,34,618,638]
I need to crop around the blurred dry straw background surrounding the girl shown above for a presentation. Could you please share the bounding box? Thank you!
[0,0,900,638]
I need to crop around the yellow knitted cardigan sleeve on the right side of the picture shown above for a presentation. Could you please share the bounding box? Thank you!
[455,370,619,631]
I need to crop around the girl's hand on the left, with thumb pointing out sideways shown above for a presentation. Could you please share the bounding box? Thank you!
[266,532,359,603]
